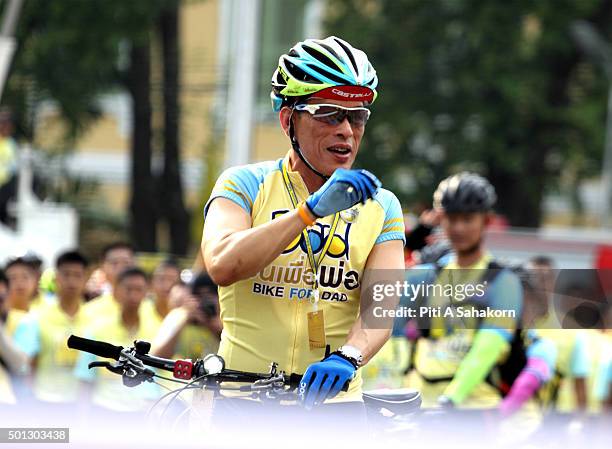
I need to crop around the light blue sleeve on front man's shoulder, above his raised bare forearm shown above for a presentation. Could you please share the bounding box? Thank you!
[204,165,261,216]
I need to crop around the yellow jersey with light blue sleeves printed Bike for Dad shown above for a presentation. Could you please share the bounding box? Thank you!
[205,155,404,400]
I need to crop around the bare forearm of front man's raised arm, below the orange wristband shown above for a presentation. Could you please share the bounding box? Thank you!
[204,211,306,285]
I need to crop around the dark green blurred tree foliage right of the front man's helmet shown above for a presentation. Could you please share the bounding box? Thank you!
[327,0,612,226]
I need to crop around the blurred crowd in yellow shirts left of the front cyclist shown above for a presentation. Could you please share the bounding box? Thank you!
[0,242,221,413]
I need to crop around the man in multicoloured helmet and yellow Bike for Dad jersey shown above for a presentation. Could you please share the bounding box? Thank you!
[202,36,404,408]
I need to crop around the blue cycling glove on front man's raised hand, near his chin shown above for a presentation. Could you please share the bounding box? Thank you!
[306,168,382,218]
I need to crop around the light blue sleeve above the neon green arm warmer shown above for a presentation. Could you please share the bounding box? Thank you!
[481,270,523,342]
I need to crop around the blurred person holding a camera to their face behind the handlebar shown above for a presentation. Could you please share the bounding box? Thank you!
[151,273,222,359]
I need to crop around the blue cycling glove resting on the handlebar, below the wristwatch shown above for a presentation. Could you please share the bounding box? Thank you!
[300,354,357,410]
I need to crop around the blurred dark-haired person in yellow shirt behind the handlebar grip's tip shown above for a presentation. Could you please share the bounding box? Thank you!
[14,251,91,411]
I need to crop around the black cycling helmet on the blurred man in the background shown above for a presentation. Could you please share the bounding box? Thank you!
[434,172,497,212]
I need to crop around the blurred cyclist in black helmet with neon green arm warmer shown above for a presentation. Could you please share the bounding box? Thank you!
[394,172,523,407]
